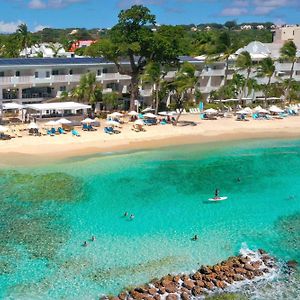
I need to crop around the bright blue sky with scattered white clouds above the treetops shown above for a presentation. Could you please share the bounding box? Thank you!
[0,0,300,33]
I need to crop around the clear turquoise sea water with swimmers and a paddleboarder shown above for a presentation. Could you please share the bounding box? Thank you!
[0,140,300,299]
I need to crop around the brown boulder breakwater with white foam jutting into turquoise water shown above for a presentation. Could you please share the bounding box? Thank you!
[100,249,277,300]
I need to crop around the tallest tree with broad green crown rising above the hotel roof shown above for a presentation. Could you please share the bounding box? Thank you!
[87,5,179,109]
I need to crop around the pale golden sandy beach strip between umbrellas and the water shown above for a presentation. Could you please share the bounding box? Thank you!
[0,115,300,165]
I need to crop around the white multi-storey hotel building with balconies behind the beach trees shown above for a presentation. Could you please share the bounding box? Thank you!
[0,42,300,108]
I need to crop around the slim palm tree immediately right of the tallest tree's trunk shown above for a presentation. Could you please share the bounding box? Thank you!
[141,62,167,114]
